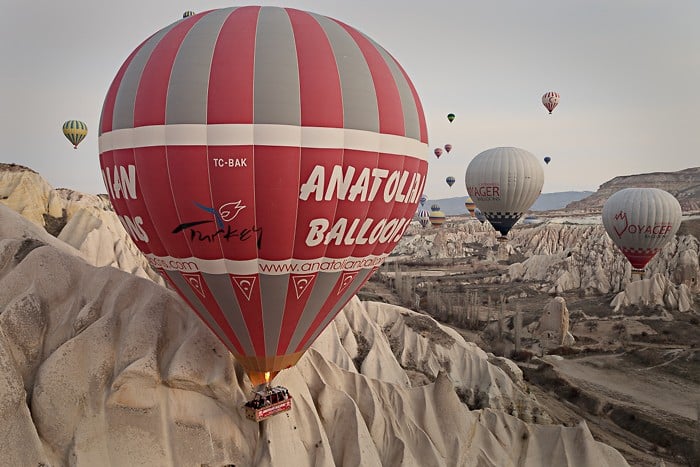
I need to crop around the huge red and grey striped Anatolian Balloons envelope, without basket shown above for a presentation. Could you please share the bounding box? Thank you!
[99,6,428,384]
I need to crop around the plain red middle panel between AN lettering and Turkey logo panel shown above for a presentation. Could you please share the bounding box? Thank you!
[134,146,191,258]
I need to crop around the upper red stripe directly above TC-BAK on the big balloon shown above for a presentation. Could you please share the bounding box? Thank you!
[207,6,260,124]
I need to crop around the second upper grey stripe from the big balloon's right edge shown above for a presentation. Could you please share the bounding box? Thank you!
[311,13,379,133]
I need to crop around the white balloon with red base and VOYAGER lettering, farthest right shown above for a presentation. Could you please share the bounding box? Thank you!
[602,188,681,275]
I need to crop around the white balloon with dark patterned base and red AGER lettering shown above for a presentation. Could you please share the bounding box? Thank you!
[464,148,544,241]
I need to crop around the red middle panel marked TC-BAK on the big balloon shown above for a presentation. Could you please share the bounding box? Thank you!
[207,146,258,262]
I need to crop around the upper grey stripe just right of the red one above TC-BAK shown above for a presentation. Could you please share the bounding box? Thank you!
[253,7,301,126]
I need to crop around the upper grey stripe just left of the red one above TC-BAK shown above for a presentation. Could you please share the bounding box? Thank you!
[165,8,233,125]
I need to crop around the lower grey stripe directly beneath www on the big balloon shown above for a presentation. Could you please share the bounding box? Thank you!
[258,274,289,355]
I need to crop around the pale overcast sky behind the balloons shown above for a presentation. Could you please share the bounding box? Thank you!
[0,0,700,199]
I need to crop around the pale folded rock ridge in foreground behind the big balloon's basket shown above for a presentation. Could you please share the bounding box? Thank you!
[0,206,626,466]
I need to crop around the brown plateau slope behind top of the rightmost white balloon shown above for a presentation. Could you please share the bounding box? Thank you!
[566,167,700,212]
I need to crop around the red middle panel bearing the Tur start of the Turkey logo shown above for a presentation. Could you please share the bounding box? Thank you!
[167,146,223,260]
